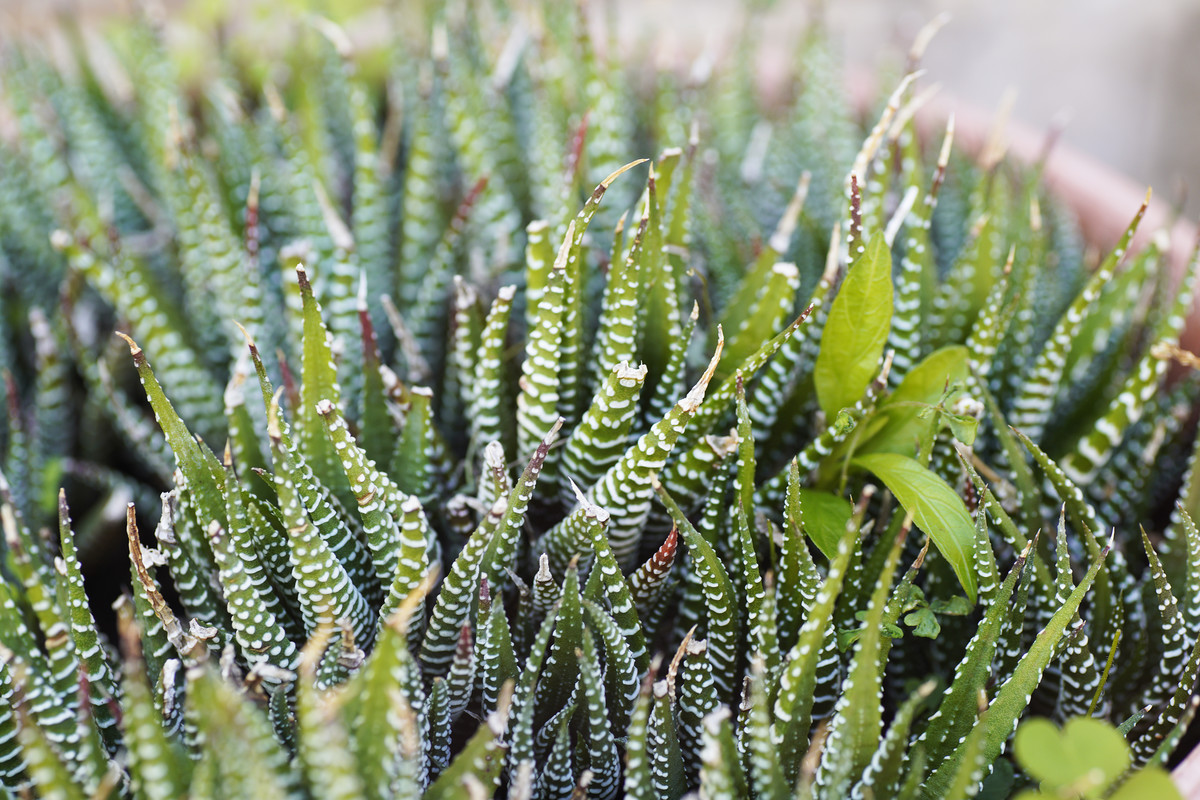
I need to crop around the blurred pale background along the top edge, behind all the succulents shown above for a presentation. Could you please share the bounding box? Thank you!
[0,0,1200,218]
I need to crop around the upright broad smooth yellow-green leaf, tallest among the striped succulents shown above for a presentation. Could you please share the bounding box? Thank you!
[814,235,892,419]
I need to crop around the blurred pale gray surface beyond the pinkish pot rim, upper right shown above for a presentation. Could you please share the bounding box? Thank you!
[832,0,1200,215]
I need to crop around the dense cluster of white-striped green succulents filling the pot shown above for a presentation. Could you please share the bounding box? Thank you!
[0,2,1200,800]
